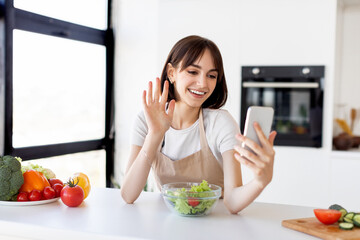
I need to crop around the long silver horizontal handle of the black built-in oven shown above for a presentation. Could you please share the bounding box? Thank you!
[243,82,319,88]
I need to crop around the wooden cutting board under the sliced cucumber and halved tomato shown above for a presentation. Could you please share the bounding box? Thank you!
[281,217,360,240]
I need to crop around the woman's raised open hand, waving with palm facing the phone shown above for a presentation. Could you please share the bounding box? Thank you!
[143,78,175,135]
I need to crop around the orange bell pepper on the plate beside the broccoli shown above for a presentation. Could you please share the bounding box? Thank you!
[19,169,50,193]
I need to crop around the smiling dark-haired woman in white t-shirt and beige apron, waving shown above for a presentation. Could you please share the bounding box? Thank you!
[121,36,276,213]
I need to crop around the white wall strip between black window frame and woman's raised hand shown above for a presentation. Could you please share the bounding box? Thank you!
[114,0,160,182]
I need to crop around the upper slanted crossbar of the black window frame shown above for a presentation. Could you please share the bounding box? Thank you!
[14,8,106,45]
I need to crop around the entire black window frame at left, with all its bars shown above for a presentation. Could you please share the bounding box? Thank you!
[0,0,115,187]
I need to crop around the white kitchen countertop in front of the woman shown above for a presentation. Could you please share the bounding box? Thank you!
[0,188,318,240]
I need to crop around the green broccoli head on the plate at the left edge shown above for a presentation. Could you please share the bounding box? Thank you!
[0,156,24,201]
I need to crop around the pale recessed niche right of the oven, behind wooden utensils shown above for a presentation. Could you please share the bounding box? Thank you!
[332,0,360,154]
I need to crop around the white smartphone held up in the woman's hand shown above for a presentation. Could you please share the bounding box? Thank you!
[242,106,274,151]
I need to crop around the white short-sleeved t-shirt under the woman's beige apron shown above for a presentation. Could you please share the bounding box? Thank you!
[131,108,240,166]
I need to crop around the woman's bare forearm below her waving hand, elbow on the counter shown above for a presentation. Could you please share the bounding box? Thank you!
[121,134,163,203]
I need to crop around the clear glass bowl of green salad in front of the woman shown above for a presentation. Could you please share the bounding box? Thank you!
[161,182,221,217]
